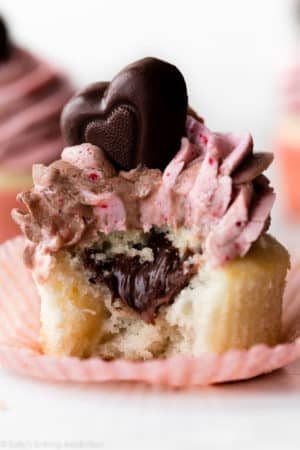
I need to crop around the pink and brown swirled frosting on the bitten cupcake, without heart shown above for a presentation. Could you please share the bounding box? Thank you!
[13,116,275,278]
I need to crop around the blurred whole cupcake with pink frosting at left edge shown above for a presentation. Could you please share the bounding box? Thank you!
[0,18,73,241]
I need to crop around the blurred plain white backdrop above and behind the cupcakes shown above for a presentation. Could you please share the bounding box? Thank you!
[0,0,300,248]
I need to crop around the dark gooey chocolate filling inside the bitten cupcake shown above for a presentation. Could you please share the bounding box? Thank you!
[83,231,195,323]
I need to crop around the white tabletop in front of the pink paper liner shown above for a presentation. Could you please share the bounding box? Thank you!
[0,363,300,450]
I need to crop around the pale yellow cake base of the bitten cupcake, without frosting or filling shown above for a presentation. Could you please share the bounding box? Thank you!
[37,232,289,360]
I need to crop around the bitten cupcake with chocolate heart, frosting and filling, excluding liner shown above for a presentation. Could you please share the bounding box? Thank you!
[13,58,289,360]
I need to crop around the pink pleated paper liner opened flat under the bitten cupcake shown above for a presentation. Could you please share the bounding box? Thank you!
[0,237,300,387]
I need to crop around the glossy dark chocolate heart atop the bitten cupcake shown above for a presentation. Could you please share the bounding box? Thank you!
[62,58,187,170]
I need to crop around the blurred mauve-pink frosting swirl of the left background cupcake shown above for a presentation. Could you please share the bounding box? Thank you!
[0,47,73,170]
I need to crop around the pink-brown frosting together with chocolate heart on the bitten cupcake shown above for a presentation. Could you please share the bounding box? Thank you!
[13,59,275,278]
